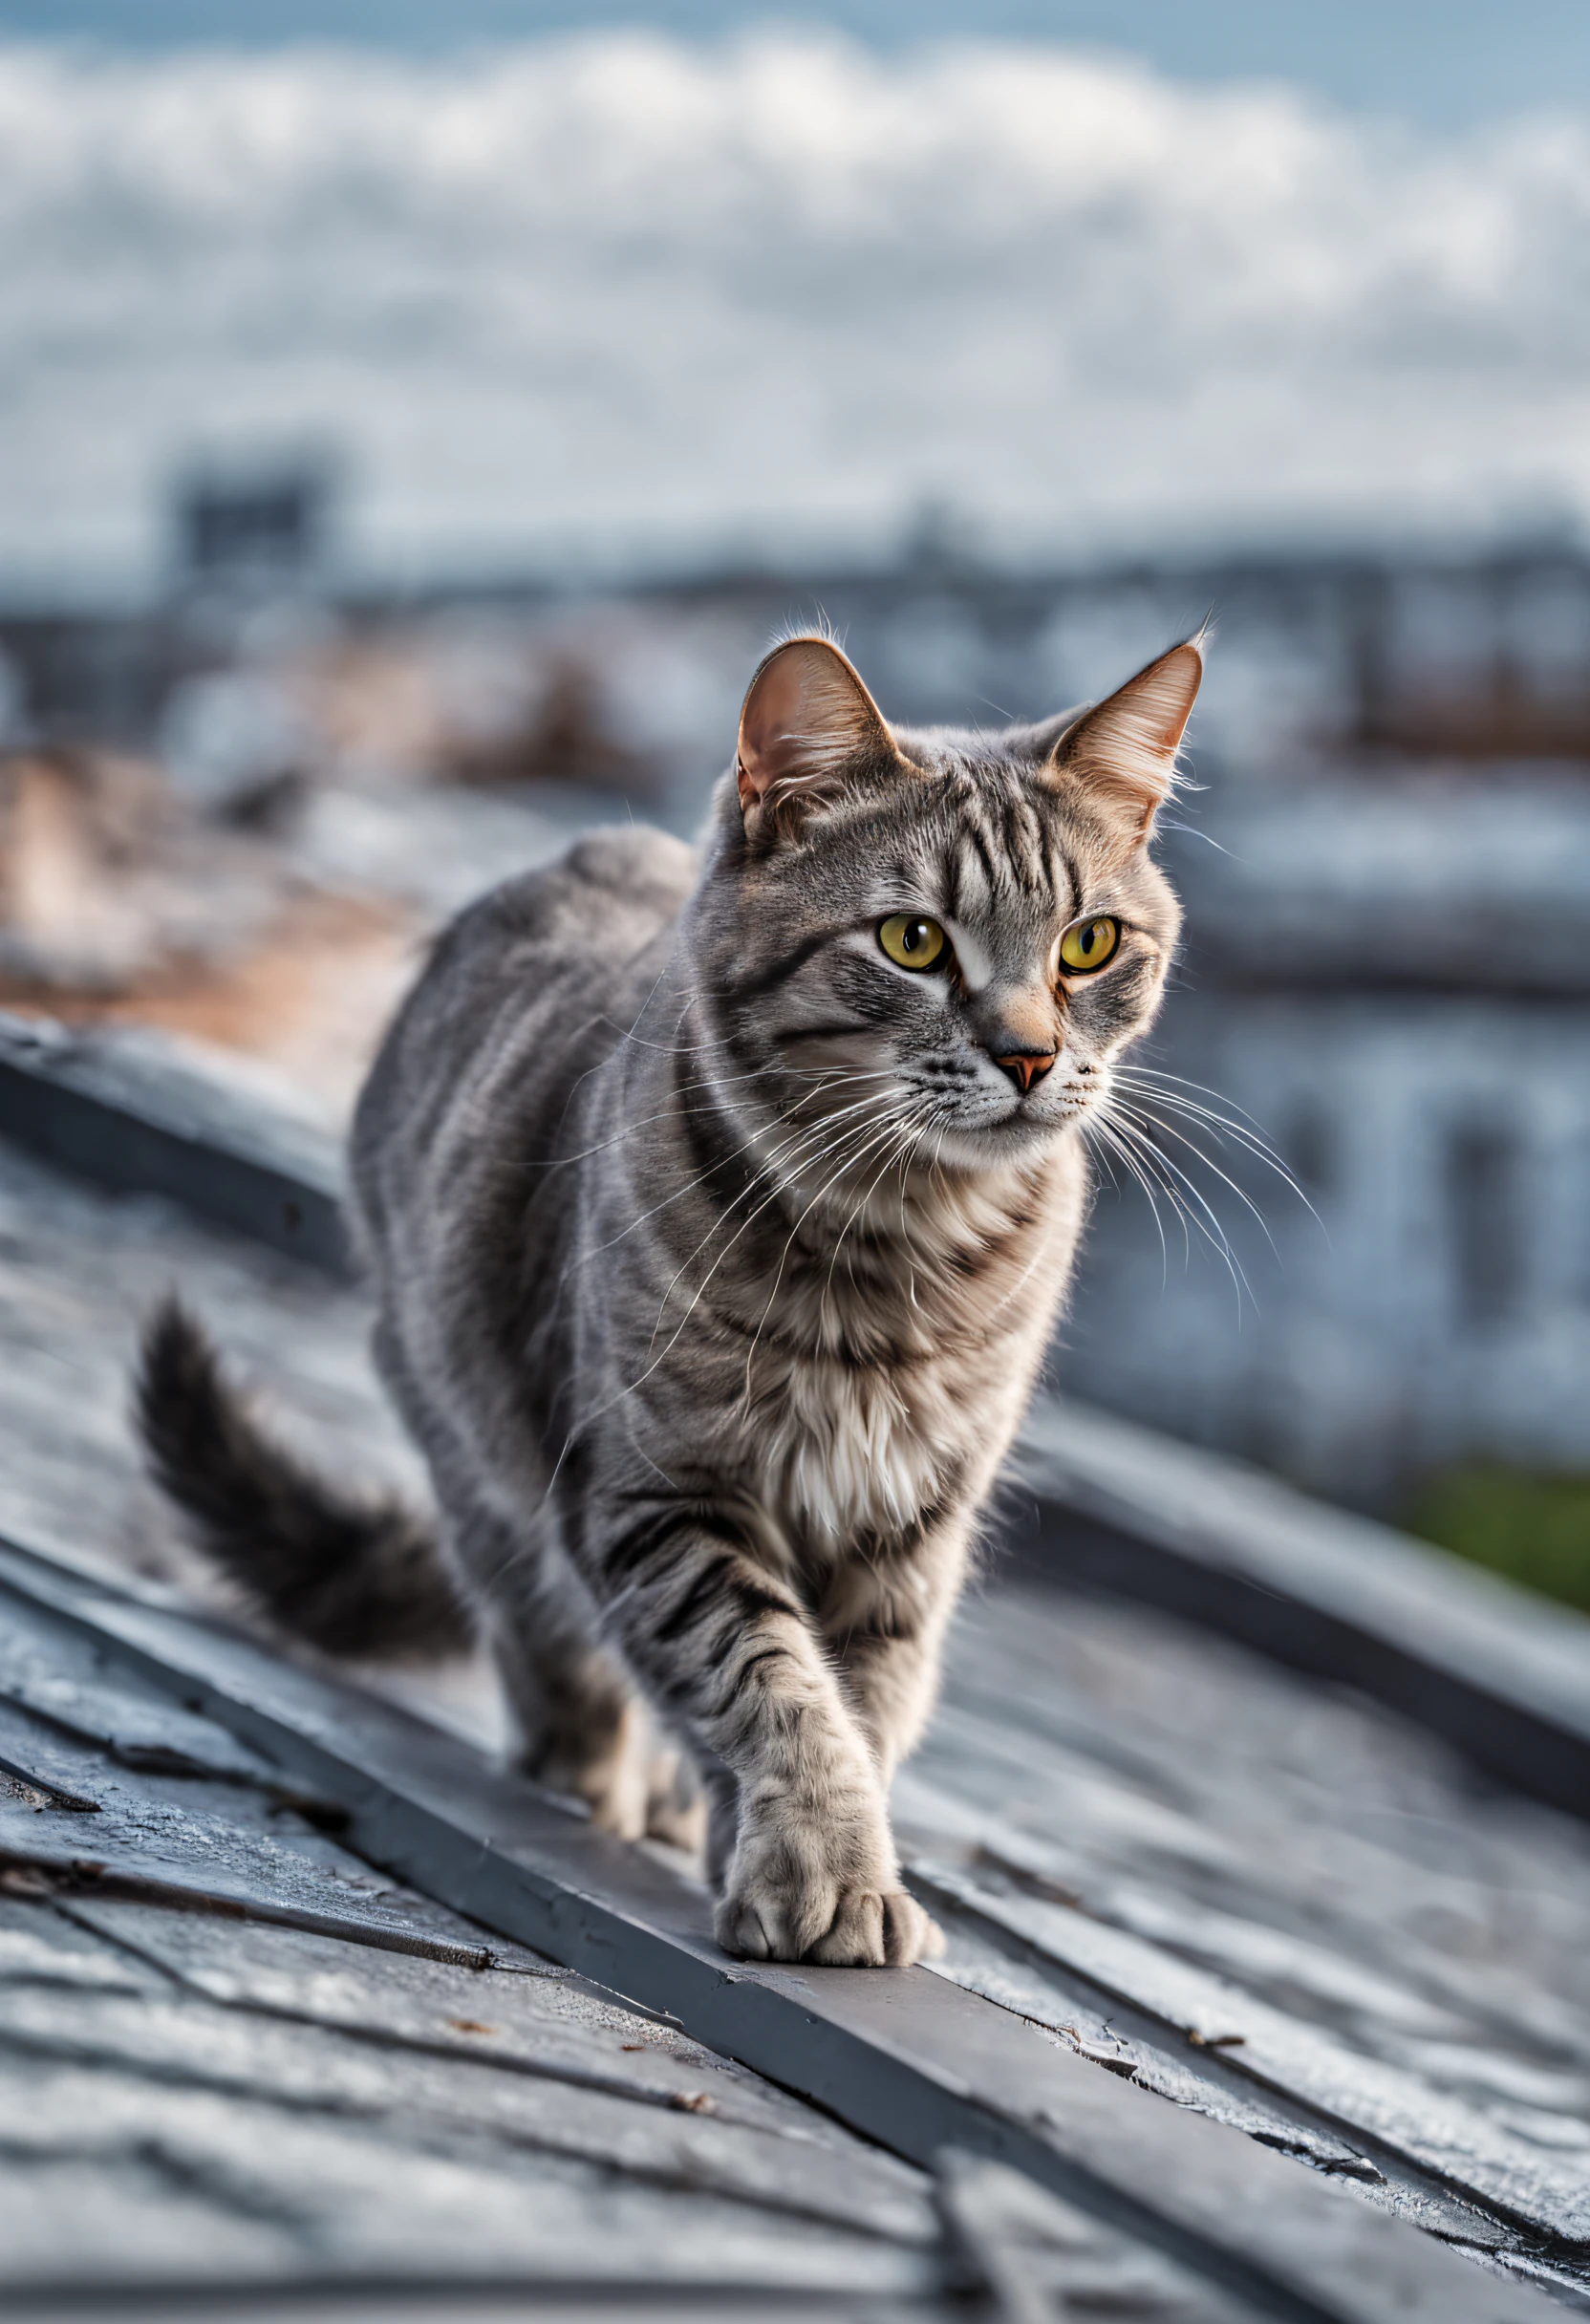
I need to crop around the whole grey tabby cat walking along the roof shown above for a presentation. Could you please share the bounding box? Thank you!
[141,636,1202,1964]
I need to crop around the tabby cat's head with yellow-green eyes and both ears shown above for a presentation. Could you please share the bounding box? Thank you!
[698,636,1204,1169]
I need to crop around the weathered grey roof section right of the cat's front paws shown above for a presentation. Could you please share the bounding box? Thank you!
[897,1589,1590,2254]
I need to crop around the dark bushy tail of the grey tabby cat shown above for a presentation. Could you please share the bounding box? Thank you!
[135,1297,474,1662]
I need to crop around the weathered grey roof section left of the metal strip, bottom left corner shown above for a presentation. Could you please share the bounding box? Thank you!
[0,1597,939,2303]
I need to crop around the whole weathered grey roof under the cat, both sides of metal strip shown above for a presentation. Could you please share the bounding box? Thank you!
[0,1026,1590,2319]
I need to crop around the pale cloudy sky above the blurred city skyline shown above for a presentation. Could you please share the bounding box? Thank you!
[0,13,1590,595]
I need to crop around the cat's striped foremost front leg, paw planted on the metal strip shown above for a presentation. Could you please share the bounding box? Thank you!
[602,1504,930,1969]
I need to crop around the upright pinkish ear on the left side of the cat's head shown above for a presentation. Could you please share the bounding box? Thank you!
[737,636,904,839]
